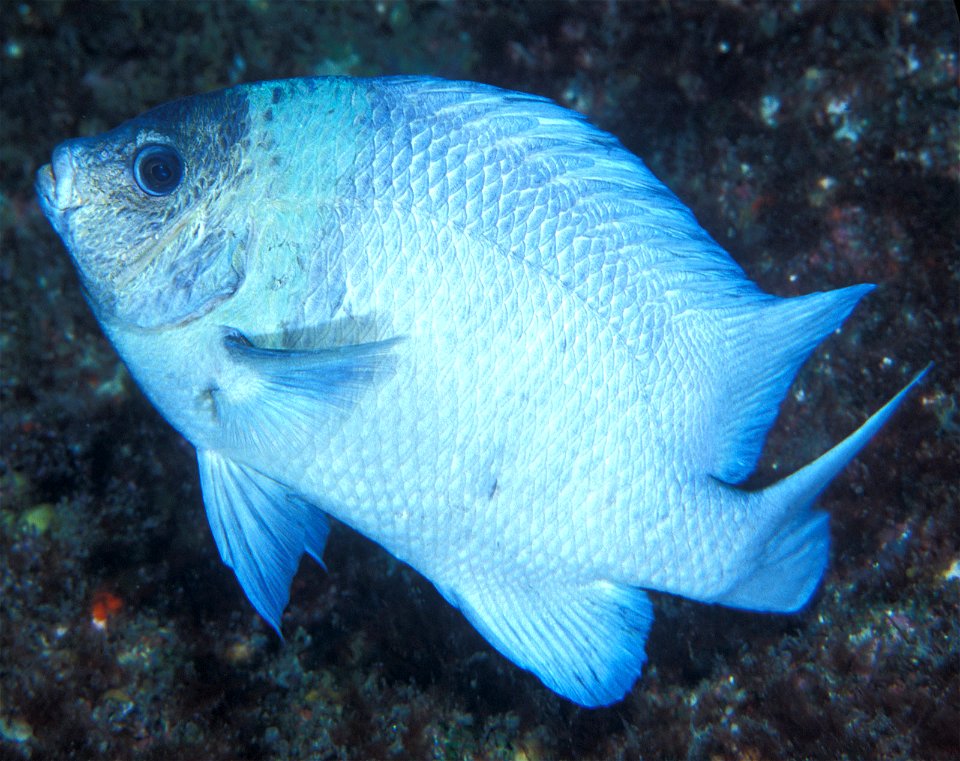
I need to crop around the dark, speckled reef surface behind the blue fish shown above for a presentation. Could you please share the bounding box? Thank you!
[0,0,960,761]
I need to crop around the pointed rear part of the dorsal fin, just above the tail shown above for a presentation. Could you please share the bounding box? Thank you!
[703,285,873,484]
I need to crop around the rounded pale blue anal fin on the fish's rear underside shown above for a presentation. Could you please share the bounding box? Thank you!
[441,581,653,707]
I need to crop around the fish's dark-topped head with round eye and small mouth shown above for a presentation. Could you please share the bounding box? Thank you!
[36,90,250,328]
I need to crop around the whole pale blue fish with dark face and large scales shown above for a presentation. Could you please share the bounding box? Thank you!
[36,77,927,707]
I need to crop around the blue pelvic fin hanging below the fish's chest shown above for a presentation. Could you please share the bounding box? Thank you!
[197,450,329,634]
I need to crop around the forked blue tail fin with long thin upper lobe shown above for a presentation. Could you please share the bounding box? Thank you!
[713,365,930,613]
